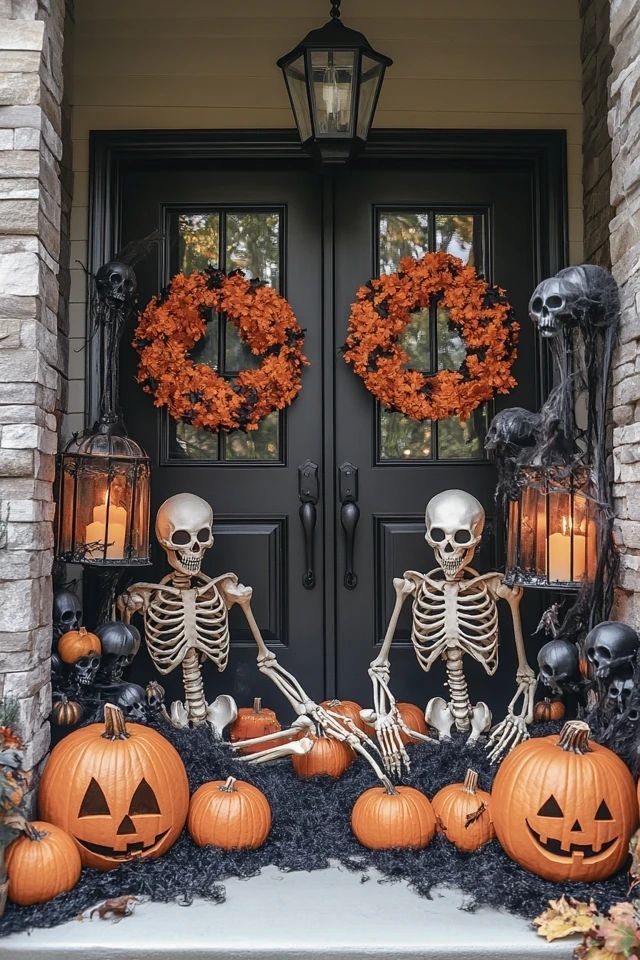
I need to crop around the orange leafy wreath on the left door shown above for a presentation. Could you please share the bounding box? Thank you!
[133,269,308,432]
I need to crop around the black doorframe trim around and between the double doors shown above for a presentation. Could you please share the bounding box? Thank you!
[86,130,568,695]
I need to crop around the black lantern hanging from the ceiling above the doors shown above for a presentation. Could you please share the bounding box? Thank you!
[278,0,393,164]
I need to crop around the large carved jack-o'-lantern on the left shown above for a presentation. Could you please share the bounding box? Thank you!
[39,703,189,870]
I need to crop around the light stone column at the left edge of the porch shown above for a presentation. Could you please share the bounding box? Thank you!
[0,0,65,769]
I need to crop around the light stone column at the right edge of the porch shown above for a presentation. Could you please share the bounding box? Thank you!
[609,0,640,627]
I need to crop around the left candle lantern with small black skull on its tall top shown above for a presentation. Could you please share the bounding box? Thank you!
[56,261,150,576]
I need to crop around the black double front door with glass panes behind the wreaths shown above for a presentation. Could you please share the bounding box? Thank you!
[118,150,539,713]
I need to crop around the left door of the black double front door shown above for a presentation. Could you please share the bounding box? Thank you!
[121,164,325,708]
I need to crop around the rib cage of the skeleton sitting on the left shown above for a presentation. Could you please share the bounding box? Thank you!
[141,573,232,673]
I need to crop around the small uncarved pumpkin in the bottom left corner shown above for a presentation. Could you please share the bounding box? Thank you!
[7,820,82,907]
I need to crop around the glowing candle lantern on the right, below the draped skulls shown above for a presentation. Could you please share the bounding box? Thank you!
[506,467,598,590]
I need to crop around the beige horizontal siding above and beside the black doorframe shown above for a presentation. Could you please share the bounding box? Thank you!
[69,0,582,429]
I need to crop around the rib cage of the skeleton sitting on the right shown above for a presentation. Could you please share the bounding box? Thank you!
[405,567,502,676]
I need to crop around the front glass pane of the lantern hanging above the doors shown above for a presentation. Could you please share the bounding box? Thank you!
[309,50,357,137]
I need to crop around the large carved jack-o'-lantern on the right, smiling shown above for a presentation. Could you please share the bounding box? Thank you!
[490,720,638,883]
